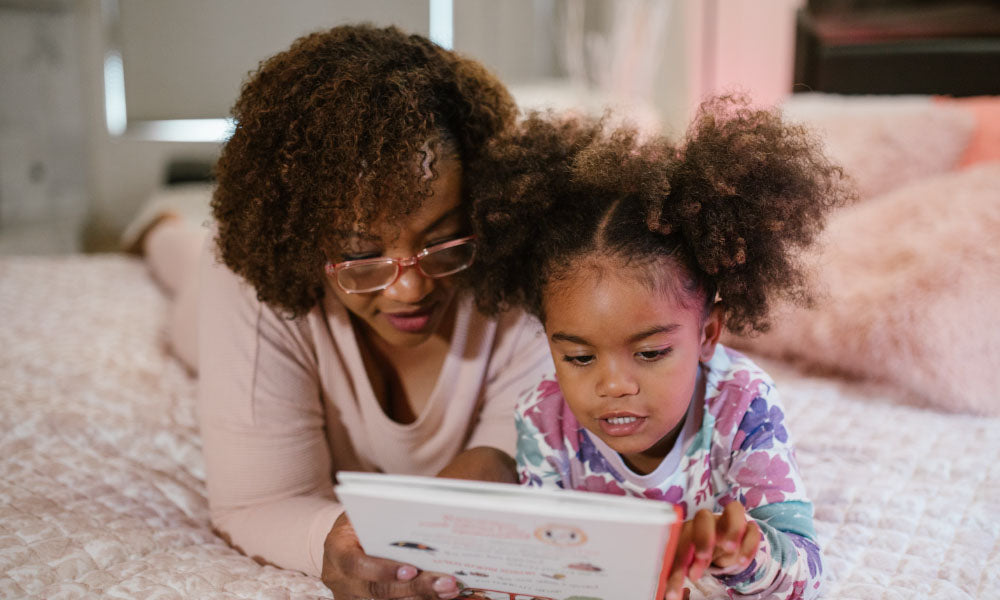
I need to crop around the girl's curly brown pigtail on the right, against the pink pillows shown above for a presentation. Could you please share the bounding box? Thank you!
[649,97,848,333]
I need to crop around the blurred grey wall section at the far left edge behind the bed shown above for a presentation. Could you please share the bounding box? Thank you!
[0,1,87,252]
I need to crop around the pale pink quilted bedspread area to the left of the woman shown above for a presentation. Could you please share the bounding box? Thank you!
[0,255,330,599]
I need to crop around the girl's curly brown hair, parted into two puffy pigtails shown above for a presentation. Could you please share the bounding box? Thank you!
[471,97,850,333]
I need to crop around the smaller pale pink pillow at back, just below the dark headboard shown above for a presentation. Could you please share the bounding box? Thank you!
[782,94,976,199]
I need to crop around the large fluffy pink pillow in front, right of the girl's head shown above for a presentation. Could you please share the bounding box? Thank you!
[724,163,1000,415]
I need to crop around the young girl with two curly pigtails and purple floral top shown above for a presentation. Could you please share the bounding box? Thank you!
[472,99,845,599]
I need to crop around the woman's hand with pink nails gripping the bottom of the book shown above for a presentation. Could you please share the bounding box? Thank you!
[322,513,458,600]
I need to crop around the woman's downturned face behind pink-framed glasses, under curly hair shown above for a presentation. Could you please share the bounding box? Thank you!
[326,158,468,347]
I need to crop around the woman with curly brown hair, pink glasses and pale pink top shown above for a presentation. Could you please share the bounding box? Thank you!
[145,26,551,600]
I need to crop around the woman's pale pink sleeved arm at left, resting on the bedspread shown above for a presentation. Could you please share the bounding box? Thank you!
[198,244,341,575]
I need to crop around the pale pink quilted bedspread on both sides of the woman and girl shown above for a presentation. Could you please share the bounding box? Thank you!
[0,255,1000,600]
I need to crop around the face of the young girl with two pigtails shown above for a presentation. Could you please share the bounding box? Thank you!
[543,257,721,473]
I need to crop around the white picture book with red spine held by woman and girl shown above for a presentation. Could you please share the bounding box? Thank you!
[336,471,683,600]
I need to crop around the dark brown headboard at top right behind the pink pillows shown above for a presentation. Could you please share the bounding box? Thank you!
[793,0,1000,96]
